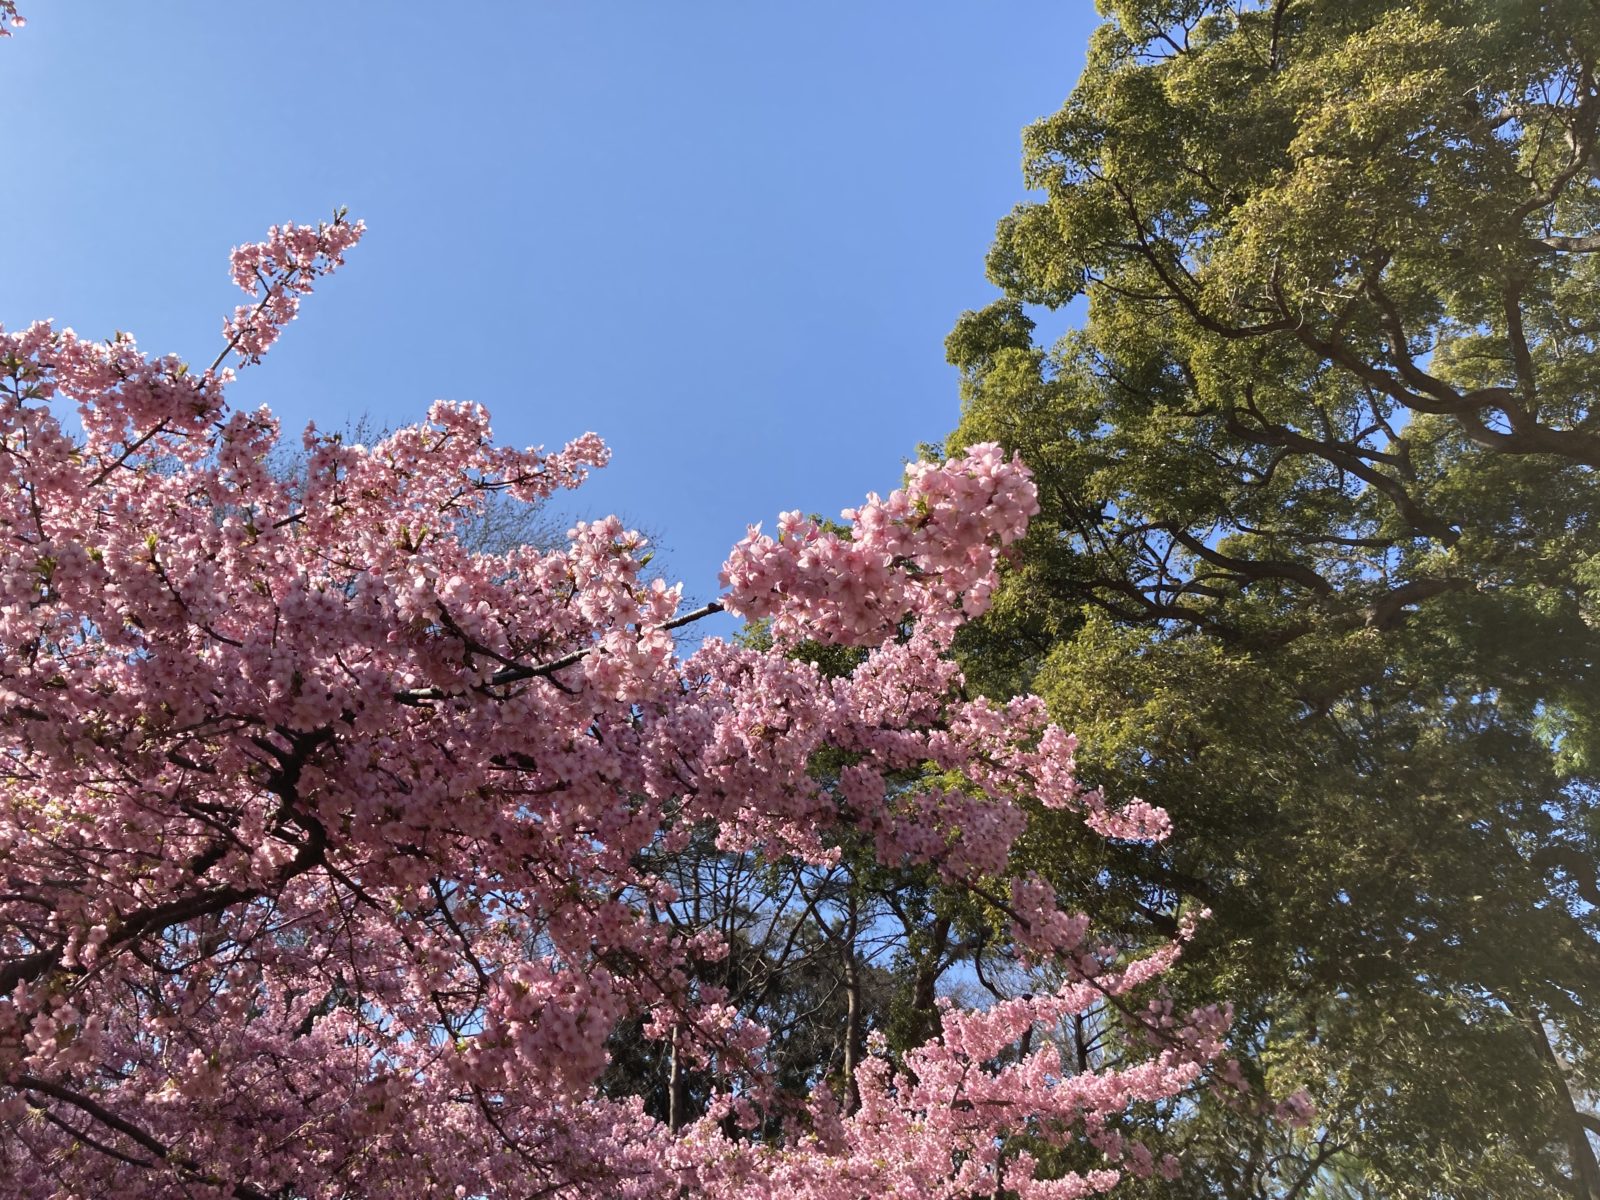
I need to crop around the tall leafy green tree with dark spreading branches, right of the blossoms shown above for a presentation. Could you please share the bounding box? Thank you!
[947,0,1600,1200]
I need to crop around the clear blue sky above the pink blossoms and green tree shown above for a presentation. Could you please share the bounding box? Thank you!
[0,0,1094,630]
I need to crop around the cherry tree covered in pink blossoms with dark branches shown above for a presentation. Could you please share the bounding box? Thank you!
[0,21,1227,1200]
